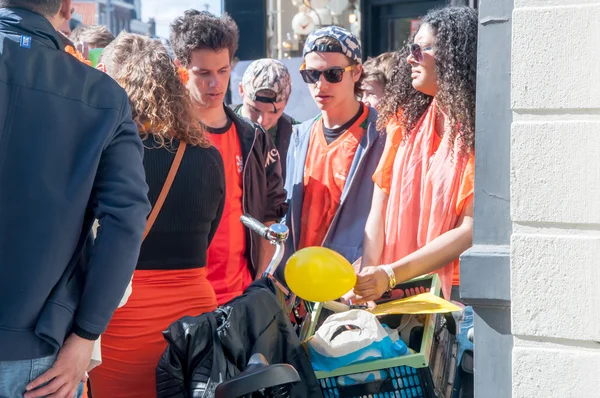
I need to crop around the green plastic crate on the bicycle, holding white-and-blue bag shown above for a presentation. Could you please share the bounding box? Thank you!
[302,274,453,398]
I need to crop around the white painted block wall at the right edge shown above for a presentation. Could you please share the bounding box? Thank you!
[510,0,600,398]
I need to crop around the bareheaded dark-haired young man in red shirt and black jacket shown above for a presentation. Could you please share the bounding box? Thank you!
[171,10,287,304]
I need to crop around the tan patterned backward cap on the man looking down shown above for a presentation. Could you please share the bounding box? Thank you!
[242,58,292,103]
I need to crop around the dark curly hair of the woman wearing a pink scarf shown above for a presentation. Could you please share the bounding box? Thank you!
[378,7,478,155]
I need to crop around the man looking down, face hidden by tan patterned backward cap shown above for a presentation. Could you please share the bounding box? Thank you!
[232,58,300,178]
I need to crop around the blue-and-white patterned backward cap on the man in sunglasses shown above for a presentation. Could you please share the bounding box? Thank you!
[302,26,362,63]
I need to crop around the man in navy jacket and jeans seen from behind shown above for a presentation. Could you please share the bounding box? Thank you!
[0,0,150,398]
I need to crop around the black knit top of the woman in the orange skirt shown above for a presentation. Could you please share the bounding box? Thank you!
[137,137,225,270]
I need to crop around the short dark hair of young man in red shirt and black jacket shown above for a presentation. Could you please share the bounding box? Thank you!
[171,10,239,66]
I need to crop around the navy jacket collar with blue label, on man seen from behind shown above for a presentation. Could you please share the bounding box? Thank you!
[0,8,64,50]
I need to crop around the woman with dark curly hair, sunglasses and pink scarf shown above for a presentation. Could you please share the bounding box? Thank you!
[350,7,477,302]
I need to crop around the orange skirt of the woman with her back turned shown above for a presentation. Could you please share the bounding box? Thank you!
[90,268,217,398]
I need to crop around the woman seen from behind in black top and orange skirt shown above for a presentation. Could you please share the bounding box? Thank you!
[90,33,225,398]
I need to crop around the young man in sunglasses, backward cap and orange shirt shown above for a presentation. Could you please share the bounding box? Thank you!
[279,26,385,277]
